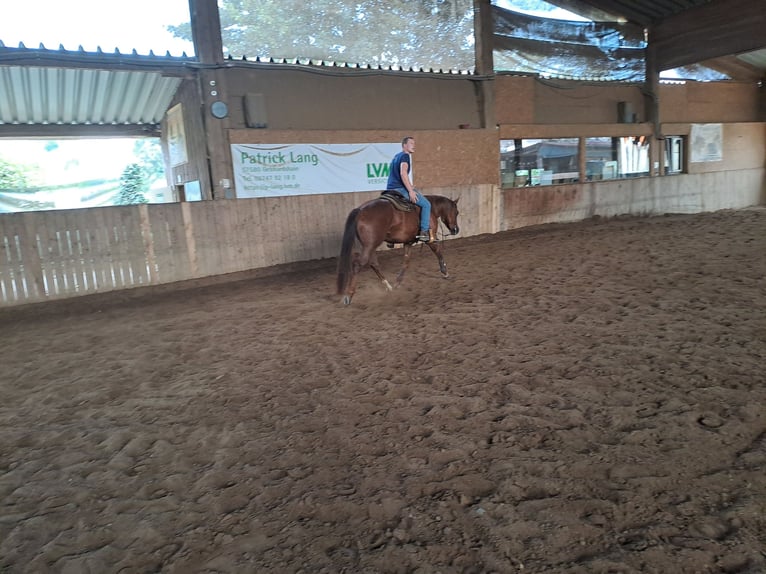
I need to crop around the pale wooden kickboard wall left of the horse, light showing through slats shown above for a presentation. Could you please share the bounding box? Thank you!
[0,194,366,306]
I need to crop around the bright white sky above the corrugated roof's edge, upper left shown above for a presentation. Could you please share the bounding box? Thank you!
[0,0,194,56]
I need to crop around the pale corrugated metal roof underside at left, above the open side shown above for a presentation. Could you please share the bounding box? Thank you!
[0,66,181,125]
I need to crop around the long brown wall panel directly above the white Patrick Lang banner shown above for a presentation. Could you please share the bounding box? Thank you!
[226,67,481,131]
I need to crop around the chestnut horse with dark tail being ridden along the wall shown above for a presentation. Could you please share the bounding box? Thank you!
[337,195,460,305]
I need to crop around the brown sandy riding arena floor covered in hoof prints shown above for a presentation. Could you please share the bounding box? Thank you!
[0,209,766,574]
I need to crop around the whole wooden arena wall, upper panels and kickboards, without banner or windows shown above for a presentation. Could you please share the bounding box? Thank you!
[0,69,766,306]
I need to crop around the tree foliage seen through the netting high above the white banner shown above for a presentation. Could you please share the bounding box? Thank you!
[168,0,474,70]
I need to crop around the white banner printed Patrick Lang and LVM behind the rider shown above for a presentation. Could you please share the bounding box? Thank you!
[231,143,402,197]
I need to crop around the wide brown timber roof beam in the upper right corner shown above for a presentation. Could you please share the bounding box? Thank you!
[649,0,766,70]
